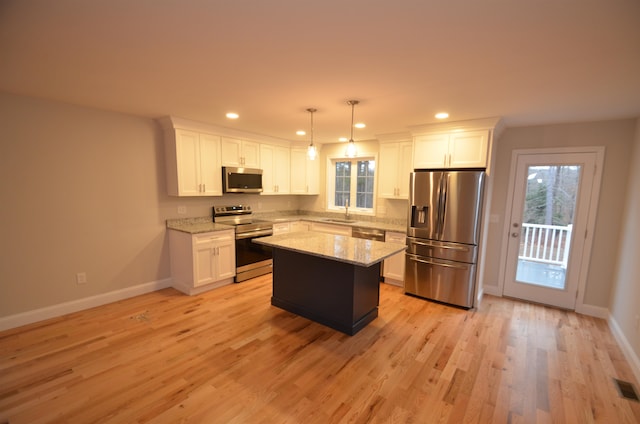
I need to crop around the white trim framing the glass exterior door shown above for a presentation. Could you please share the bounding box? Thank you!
[498,146,605,313]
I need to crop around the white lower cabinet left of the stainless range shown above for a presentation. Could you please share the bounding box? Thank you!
[169,229,236,295]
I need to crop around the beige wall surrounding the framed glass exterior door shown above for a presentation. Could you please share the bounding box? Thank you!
[484,119,635,308]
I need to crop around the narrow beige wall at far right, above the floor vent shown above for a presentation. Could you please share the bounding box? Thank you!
[609,119,640,366]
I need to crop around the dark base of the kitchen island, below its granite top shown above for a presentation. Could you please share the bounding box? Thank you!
[271,248,380,336]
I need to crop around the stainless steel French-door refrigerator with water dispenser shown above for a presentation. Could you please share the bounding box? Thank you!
[404,170,486,308]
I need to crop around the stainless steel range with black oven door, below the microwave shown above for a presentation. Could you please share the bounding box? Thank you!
[212,205,273,283]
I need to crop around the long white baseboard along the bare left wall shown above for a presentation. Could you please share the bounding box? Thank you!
[0,278,172,331]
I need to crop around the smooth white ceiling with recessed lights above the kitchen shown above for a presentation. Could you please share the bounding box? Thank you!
[0,0,640,143]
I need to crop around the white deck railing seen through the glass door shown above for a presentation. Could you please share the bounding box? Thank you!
[518,224,573,268]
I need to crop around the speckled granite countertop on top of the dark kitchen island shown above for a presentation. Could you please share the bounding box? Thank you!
[253,231,405,266]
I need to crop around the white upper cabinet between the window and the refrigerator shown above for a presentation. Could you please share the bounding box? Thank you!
[378,141,413,199]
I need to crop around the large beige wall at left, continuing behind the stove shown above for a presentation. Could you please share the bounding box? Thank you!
[0,93,297,317]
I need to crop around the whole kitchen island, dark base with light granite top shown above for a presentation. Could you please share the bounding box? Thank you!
[254,232,405,335]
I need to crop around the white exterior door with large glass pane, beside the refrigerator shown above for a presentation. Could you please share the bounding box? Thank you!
[503,152,599,310]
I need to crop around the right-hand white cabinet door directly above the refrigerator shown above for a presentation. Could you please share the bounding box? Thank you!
[449,131,489,168]
